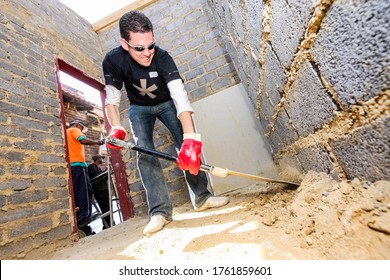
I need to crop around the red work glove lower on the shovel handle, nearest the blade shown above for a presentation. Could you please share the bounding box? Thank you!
[176,133,202,175]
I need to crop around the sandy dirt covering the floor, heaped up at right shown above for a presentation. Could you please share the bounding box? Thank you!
[41,172,390,260]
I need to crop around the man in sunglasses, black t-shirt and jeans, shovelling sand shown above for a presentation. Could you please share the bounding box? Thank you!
[103,11,229,235]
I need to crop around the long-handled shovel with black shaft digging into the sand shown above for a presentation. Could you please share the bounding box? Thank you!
[106,137,300,188]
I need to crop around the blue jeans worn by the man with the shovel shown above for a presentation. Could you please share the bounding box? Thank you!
[129,101,211,220]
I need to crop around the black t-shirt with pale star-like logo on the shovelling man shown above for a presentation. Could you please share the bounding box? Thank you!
[103,46,181,106]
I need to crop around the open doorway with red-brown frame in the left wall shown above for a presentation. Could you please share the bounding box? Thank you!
[56,59,134,236]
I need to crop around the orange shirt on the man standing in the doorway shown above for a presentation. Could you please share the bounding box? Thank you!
[66,127,86,166]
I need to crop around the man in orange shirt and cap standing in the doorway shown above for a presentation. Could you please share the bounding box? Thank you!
[66,120,105,235]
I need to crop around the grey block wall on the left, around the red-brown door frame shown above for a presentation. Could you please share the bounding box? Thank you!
[0,0,102,259]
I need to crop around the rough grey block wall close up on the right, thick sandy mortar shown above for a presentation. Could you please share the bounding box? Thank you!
[208,0,390,181]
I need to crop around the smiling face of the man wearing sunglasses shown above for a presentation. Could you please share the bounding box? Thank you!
[120,32,154,67]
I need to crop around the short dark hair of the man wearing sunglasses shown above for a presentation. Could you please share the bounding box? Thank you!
[119,11,153,41]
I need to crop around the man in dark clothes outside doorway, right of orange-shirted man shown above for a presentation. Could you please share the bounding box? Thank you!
[88,155,111,229]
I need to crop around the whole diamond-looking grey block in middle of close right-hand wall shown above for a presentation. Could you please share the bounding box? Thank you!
[285,61,337,137]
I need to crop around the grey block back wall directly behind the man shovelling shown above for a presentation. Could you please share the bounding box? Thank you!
[98,0,240,215]
